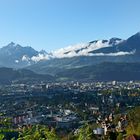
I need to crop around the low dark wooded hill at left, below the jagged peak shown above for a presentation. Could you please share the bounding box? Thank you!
[0,67,54,84]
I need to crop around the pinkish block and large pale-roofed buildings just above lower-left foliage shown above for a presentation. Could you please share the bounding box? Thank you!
[12,109,79,128]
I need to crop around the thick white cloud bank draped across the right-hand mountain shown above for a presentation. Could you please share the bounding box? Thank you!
[52,40,135,58]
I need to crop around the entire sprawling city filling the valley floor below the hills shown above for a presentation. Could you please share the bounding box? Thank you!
[0,81,140,139]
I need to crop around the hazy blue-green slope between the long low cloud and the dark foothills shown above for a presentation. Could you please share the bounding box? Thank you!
[26,55,140,75]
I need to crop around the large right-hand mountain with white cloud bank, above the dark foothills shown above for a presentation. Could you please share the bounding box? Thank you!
[27,33,140,75]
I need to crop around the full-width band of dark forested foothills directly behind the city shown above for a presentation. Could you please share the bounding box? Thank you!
[0,62,140,84]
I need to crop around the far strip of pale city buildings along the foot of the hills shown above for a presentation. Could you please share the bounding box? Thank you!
[0,81,140,94]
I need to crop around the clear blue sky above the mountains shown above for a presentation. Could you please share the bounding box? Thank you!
[0,0,140,52]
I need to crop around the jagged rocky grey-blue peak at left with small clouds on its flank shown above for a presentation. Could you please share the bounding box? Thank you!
[0,42,47,68]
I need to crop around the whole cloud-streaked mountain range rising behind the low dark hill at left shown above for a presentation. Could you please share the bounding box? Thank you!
[0,32,140,80]
